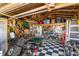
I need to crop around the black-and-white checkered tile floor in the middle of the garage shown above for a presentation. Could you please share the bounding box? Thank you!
[33,41,64,56]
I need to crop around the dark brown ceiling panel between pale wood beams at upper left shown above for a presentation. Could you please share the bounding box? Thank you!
[6,3,44,16]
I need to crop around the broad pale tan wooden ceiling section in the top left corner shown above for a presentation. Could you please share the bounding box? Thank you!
[0,3,29,13]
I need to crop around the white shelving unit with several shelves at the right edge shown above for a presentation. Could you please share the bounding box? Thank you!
[69,21,79,41]
